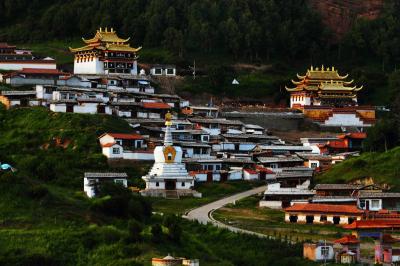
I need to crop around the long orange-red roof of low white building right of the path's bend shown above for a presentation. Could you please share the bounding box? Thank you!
[285,203,364,214]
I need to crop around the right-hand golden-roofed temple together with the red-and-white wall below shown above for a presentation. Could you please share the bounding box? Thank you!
[286,66,375,127]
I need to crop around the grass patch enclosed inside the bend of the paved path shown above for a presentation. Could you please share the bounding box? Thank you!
[213,196,345,241]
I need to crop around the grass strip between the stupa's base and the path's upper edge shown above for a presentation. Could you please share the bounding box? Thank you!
[152,181,264,214]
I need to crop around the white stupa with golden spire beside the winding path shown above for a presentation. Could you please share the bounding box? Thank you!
[141,113,201,198]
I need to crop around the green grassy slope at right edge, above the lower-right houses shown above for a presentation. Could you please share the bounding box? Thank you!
[315,147,400,191]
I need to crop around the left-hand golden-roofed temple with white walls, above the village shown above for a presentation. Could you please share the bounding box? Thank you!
[69,28,141,75]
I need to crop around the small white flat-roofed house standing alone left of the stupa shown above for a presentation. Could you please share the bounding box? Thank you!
[83,173,128,198]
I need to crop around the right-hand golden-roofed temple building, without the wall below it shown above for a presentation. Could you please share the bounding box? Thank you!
[286,66,362,109]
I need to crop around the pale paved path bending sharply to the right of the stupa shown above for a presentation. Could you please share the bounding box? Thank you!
[183,186,268,237]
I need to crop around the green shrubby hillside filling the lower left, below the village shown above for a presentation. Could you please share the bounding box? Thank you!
[0,108,310,266]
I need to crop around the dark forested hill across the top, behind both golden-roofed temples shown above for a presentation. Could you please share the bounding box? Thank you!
[0,0,400,65]
